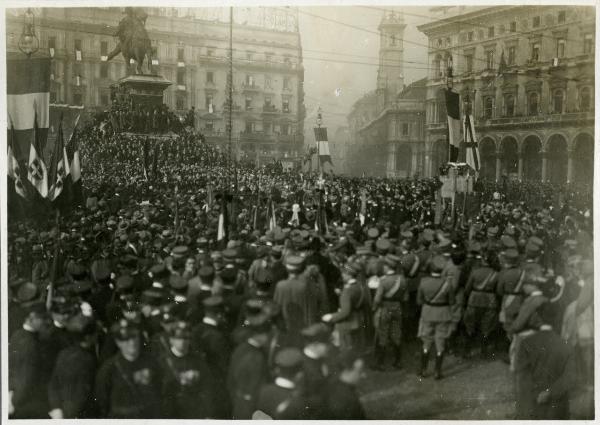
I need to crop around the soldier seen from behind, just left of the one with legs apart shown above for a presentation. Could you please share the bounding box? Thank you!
[373,254,407,370]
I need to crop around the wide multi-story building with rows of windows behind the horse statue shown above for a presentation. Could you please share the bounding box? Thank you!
[6,7,305,161]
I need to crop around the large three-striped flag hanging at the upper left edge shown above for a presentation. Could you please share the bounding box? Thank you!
[6,54,50,162]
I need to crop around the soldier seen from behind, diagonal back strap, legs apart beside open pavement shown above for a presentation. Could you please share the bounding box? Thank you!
[417,255,454,379]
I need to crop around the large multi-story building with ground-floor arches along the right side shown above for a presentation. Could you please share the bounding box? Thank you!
[418,5,596,182]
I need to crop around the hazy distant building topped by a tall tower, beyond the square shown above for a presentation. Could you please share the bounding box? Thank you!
[348,12,427,177]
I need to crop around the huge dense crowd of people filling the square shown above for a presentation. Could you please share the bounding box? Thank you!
[8,127,593,419]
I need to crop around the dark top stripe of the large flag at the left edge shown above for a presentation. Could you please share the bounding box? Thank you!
[6,55,50,95]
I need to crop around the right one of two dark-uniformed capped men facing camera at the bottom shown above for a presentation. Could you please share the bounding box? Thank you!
[159,322,216,419]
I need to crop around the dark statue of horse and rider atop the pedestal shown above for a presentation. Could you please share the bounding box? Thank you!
[107,7,152,74]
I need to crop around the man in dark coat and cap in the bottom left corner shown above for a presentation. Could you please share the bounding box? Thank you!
[8,302,50,419]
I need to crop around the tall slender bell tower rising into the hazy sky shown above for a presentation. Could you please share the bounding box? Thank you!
[377,11,406,112]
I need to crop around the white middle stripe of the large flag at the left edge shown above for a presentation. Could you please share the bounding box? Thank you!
[6,93,50,130]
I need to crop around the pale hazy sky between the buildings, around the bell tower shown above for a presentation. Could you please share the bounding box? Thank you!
[299,5,431,137]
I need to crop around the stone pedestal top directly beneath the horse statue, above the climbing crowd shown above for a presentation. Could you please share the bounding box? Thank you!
[111,74,172,108]
